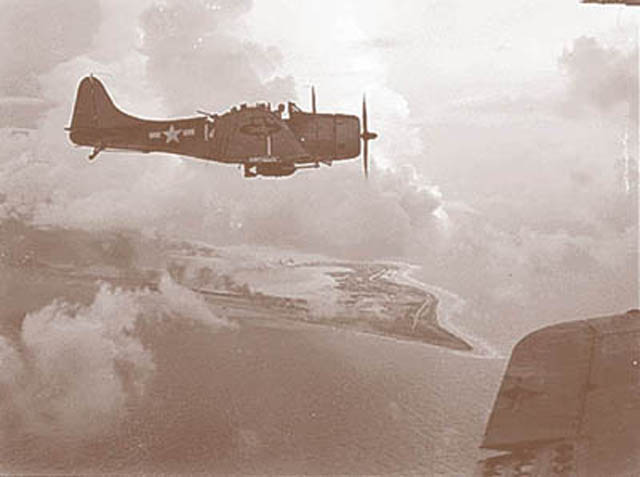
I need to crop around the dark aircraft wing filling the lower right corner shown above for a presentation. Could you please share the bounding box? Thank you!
[475,310,640,477]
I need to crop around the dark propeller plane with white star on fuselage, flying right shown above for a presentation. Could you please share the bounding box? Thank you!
[65,75,378,178]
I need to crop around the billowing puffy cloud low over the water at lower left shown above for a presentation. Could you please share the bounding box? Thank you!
[0,277,233,440]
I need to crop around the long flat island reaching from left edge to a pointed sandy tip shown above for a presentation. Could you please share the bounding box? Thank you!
[0,220,472,351]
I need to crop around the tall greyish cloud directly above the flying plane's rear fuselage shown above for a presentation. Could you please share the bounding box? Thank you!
[140,0,294,114]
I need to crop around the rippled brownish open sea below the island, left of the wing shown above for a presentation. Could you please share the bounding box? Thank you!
[0,308,502,475]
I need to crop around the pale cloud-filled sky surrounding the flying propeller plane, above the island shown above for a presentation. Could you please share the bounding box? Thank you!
[0,0,638,346]
